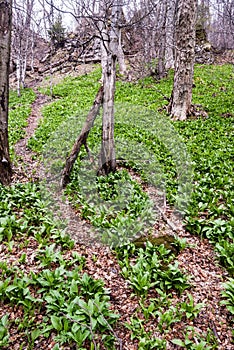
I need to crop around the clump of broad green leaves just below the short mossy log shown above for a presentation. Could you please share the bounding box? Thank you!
[116,242,189,297]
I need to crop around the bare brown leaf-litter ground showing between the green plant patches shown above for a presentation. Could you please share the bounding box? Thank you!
[0,63,234,350]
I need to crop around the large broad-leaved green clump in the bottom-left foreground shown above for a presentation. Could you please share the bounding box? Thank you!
[0,247,118,348]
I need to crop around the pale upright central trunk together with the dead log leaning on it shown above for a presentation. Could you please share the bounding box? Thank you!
[61,1,120,188]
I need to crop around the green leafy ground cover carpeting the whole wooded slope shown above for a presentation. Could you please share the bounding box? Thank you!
[0,65,234,349]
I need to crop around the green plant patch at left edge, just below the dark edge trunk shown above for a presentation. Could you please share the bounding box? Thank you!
[0,183,74,249]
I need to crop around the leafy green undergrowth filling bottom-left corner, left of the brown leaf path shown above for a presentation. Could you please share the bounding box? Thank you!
[0,184,118,349]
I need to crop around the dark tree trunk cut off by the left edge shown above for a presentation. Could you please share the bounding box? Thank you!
[0,0,12,185]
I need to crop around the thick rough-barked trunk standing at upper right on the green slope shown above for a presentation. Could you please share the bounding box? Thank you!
[169,0,197,120]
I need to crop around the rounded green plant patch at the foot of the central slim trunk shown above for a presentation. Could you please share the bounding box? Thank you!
[66,165,154,246]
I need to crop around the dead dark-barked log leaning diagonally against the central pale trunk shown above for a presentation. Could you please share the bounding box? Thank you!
[61,86,103,188]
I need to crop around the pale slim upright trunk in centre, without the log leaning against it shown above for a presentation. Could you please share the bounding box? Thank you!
[98,2,119,175]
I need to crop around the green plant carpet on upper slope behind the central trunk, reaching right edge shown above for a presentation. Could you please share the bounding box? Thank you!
[29,65,234,274]
